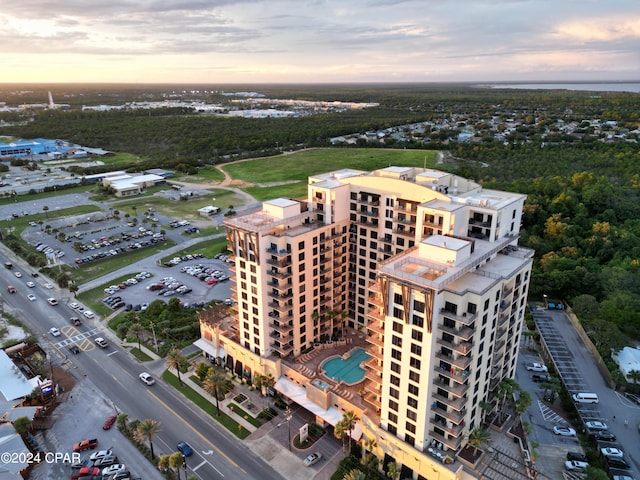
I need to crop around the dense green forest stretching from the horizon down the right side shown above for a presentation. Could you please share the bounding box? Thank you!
[0,85,640,372]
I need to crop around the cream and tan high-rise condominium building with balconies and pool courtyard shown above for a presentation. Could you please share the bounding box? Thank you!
[202,167,533,479]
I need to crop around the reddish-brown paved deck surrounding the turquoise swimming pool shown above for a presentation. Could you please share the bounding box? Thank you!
[284,328,369,408]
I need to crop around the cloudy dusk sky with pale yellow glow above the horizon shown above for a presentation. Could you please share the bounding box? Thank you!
[0,0,640,83]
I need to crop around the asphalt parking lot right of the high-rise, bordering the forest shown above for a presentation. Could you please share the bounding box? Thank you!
[518,308,640,478]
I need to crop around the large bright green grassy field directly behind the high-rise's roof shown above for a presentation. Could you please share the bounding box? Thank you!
[223,148,437,200]
